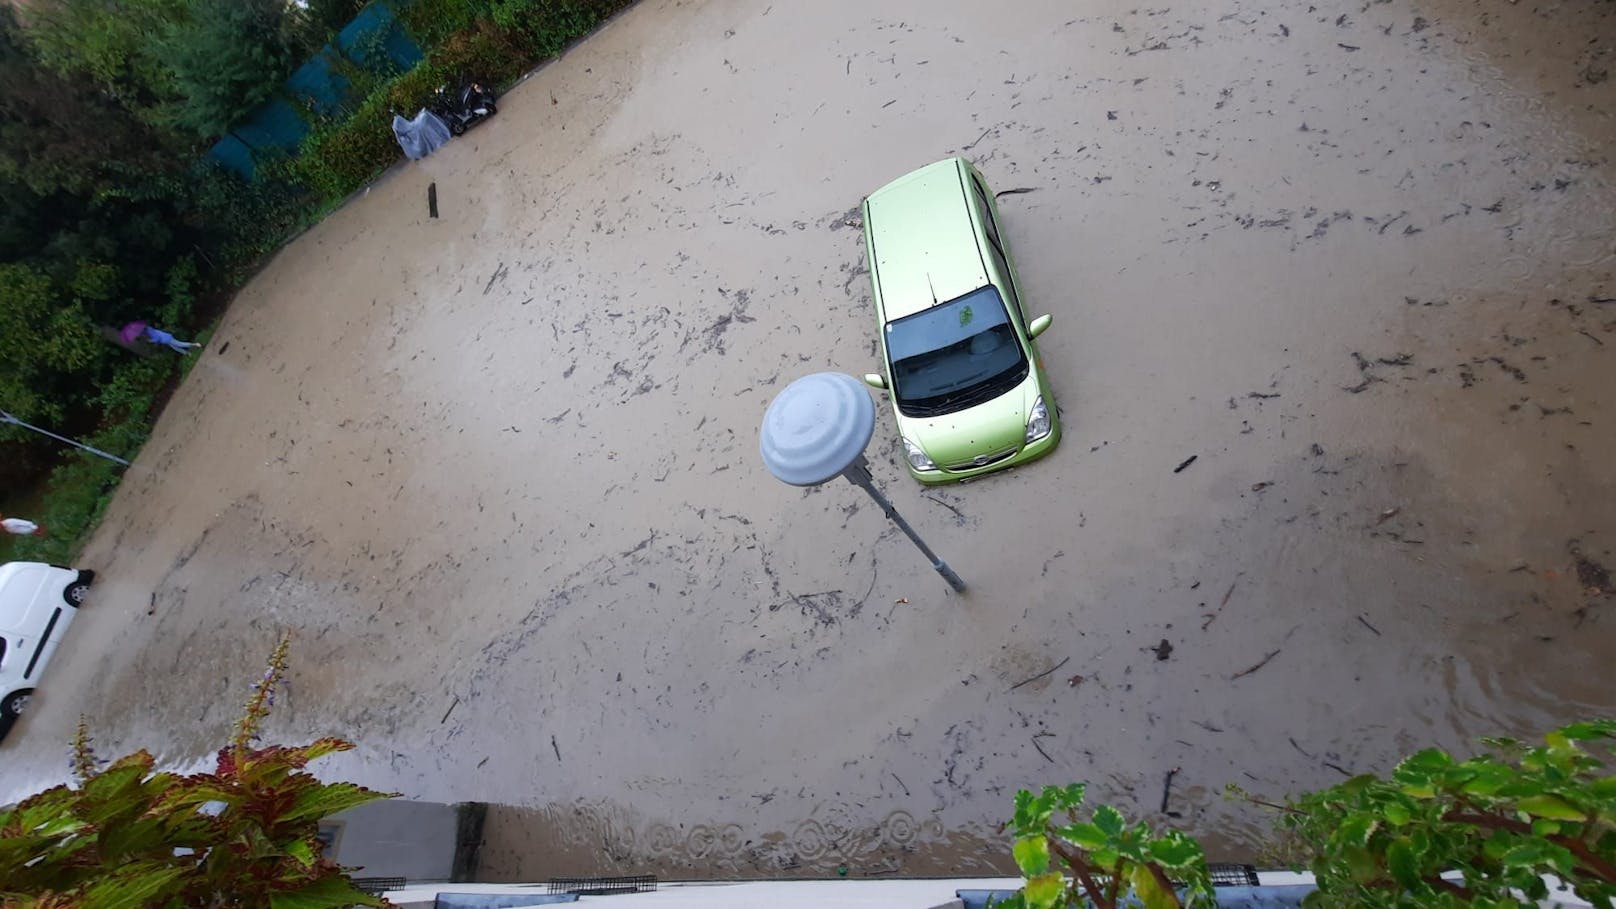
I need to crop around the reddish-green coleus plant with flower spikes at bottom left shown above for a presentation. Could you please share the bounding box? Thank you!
[0,639,388,909]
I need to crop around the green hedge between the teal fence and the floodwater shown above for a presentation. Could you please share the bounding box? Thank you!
[291,0,630,202]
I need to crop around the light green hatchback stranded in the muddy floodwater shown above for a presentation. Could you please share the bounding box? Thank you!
[865,159,1060,484]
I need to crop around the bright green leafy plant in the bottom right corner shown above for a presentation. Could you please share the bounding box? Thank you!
[1254,720,1616,909]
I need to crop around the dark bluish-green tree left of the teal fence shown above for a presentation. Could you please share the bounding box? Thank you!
[160,0,302,139]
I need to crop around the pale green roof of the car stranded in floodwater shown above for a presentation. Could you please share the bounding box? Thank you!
[865,159,989,322]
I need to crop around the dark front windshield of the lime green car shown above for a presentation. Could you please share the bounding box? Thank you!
[887,285,1026,417]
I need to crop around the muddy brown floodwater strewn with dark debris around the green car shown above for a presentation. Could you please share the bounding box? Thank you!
[0,0,1616,878]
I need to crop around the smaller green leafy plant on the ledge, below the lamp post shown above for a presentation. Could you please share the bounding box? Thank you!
[1007,783,1215,909]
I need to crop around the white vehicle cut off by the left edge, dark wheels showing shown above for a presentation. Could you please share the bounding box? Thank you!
[0,561,95,729]
